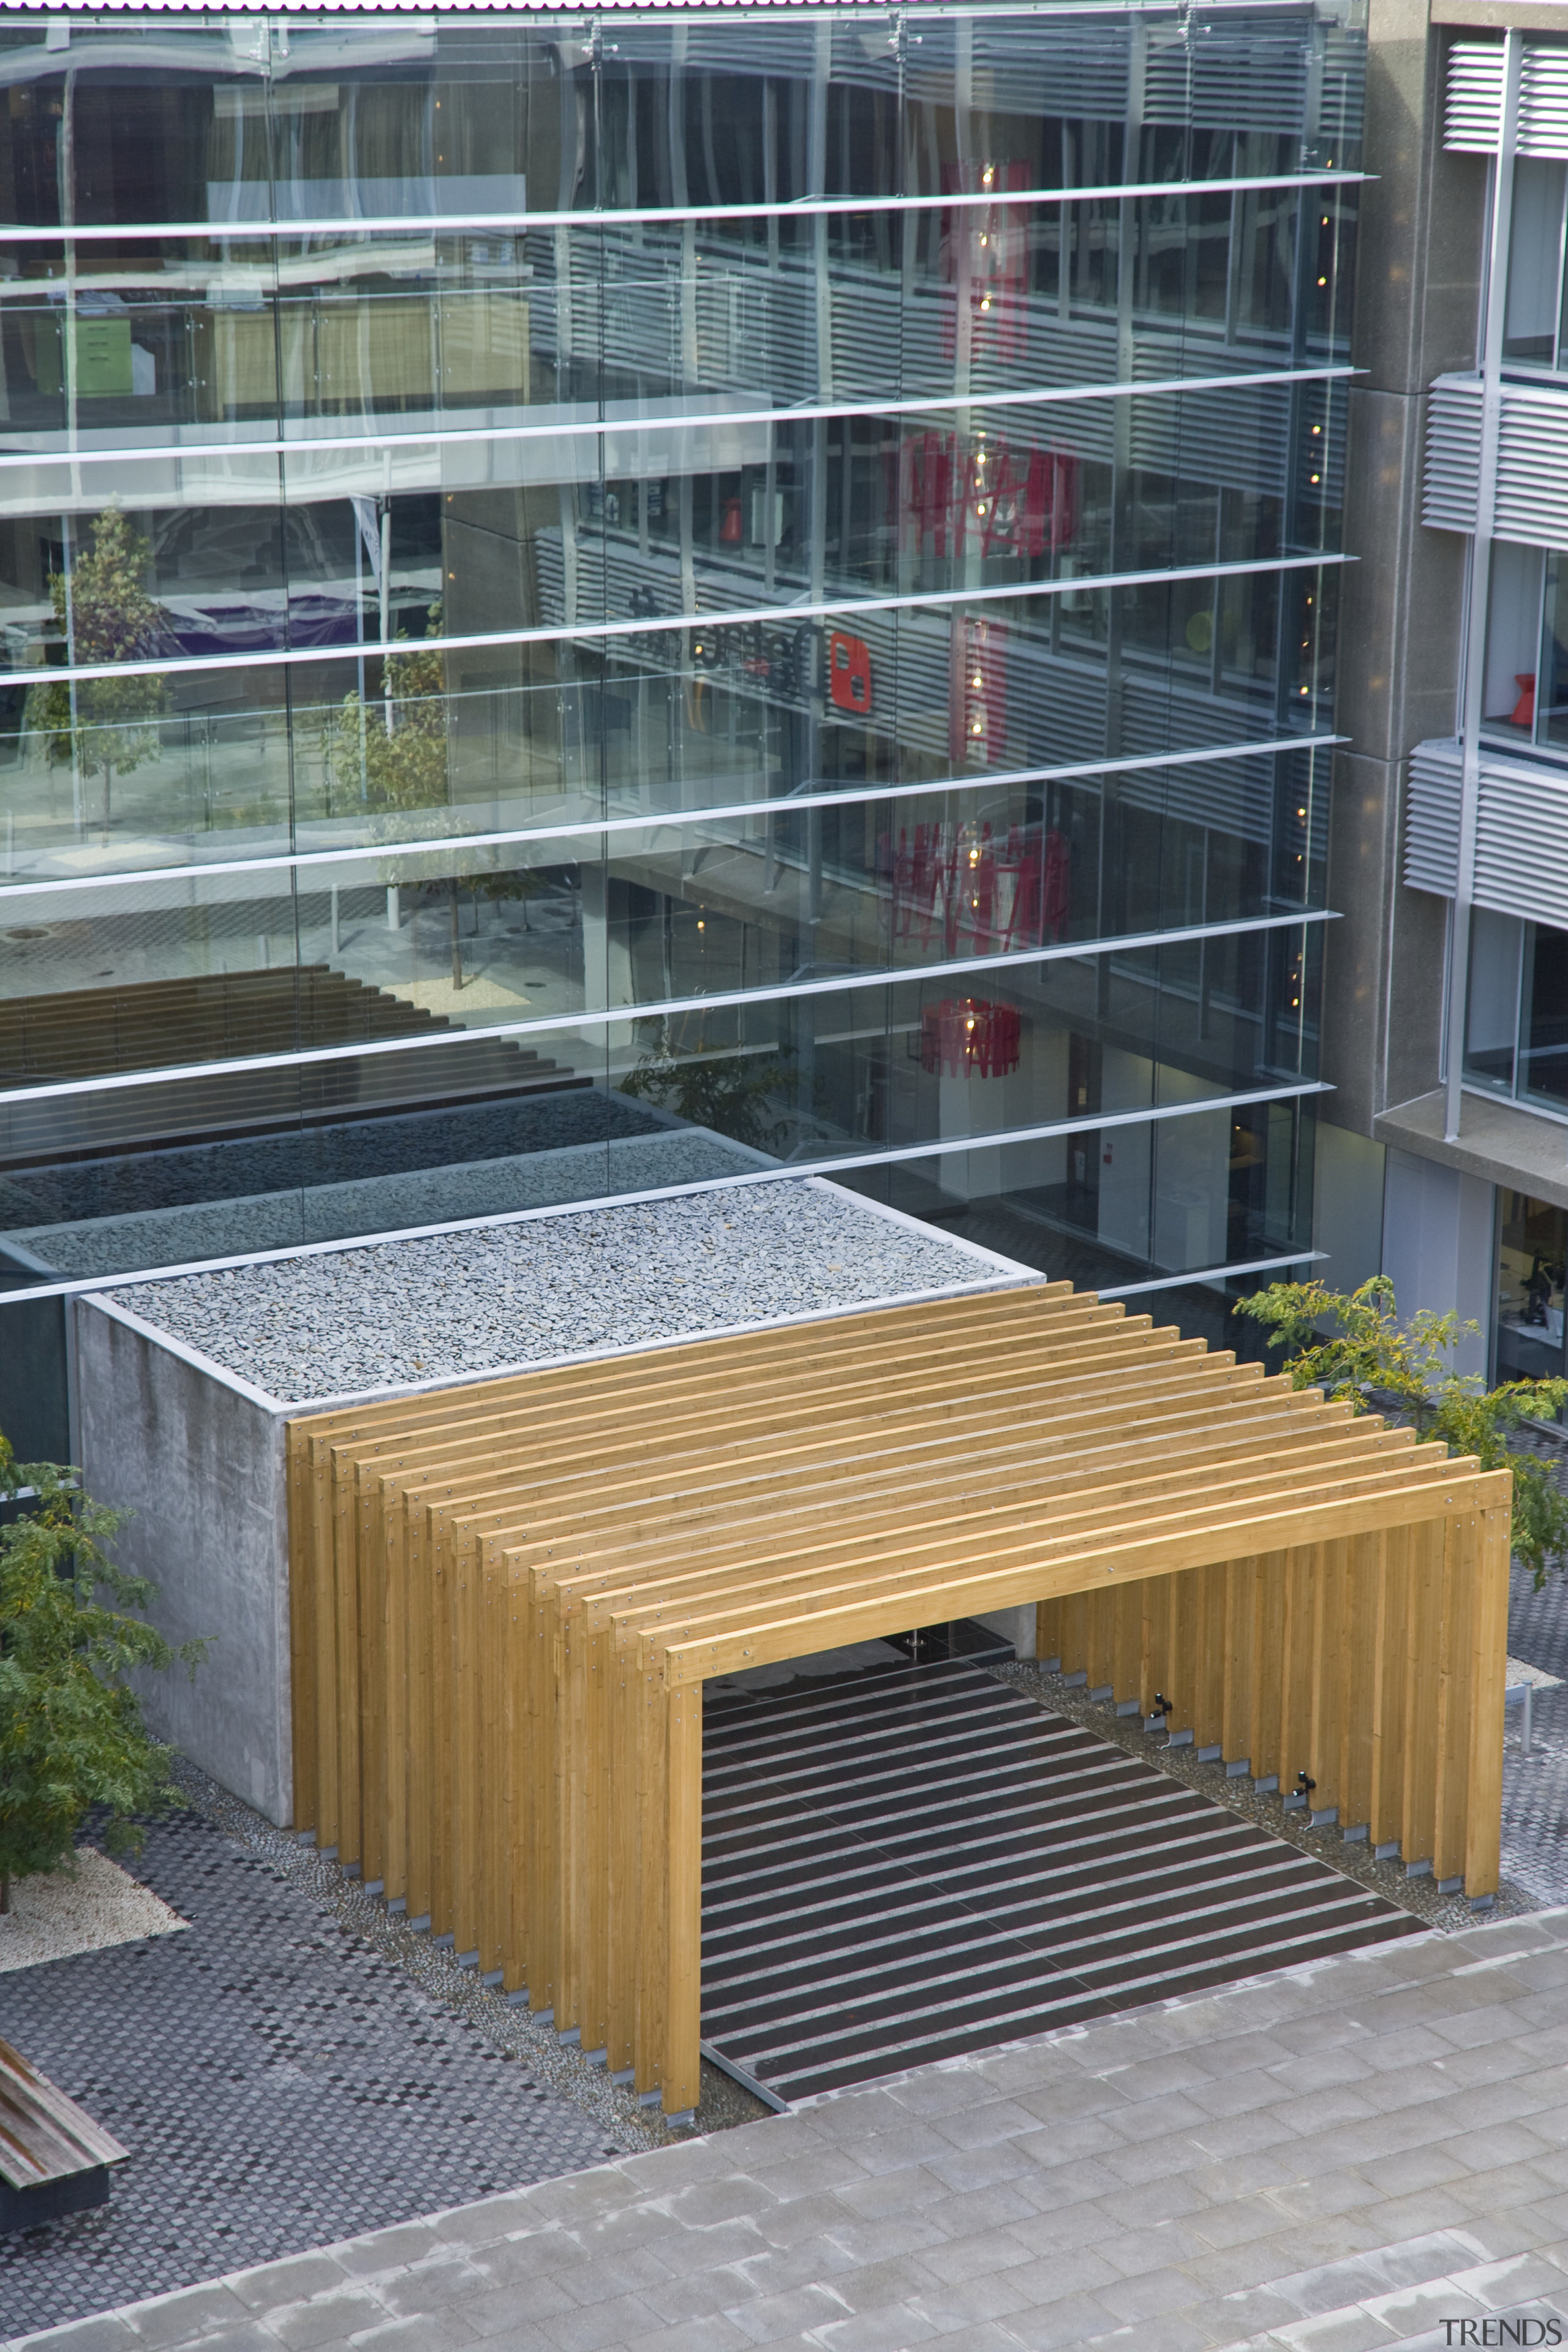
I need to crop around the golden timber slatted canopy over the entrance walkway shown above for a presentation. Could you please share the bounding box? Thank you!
[289,1282,1512,2112]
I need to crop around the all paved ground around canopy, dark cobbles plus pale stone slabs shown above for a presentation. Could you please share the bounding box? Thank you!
[0,1543,1568,2352]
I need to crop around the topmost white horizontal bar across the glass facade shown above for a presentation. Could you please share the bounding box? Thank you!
[0,167,1366,244]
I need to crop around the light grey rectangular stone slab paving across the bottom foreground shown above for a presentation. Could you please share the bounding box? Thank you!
[14,1910,1568,2352]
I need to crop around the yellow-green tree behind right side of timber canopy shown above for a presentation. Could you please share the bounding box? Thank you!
[1234,1275,1568,1593]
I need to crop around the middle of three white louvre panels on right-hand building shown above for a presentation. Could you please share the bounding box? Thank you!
[1422,376,1568,548]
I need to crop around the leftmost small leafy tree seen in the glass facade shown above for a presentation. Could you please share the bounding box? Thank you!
[28,506,169,776]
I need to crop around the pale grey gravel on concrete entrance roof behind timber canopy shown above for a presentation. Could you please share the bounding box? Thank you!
[123,1176,1006,1402]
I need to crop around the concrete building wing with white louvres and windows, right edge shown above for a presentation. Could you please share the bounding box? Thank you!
[1319,0,1568,1378]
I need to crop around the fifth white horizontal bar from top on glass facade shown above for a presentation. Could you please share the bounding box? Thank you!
[0,908,1340,1115]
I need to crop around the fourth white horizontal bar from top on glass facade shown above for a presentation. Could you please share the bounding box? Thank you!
[0,734,1349,901]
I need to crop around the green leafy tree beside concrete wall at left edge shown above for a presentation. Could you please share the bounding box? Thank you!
[0,1437,207,1912]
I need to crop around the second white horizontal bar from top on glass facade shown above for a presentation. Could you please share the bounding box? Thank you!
[0,362,1354,470]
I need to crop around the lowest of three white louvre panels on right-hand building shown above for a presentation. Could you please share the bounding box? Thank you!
[1406,743,1568,929]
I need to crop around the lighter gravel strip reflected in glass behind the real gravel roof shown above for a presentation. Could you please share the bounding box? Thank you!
[12,1126,771,1275]
